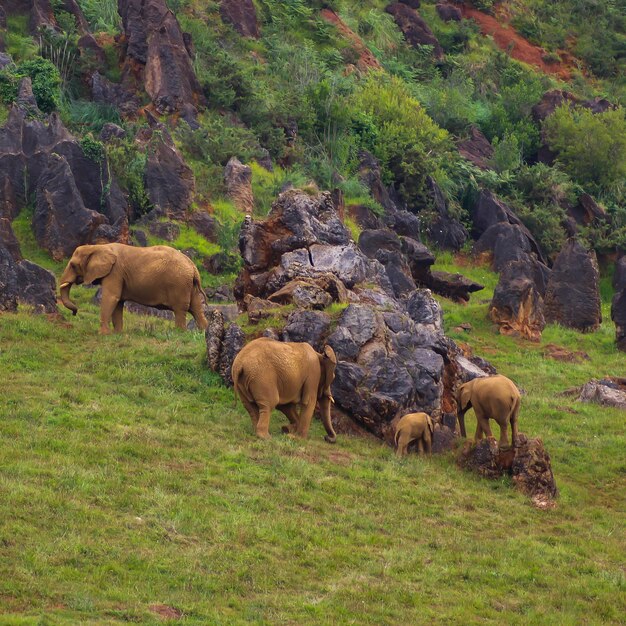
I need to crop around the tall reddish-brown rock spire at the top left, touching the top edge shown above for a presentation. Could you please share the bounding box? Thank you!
[117,0,203,114]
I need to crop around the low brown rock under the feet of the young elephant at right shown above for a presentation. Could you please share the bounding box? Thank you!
[458,433,558,509]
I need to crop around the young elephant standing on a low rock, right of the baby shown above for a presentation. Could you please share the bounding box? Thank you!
[456,375,521,448]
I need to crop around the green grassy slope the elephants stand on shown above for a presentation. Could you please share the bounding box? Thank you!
[0,258,626,626]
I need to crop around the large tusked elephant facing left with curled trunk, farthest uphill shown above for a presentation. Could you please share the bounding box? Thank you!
[60,243,208,335]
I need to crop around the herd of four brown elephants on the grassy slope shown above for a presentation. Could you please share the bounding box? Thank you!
[60,243,520,456]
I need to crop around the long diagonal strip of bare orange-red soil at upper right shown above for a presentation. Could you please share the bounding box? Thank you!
[461,5,573,80]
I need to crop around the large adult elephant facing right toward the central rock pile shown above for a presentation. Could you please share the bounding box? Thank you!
[232,337,337,443]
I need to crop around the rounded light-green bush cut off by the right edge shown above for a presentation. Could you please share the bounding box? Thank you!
[543,105,626,191]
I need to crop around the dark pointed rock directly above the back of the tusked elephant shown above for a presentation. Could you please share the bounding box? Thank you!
[138,114,196,220]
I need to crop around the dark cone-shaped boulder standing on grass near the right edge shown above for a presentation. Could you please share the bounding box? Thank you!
[545,239,602,332]
